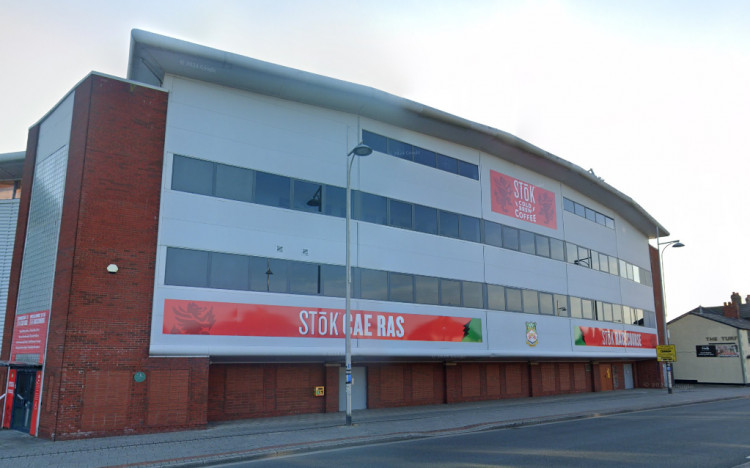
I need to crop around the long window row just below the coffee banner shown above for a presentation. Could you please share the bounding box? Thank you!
[172,155,652,286]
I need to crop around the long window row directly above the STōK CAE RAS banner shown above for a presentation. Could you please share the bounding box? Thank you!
[164,247,656,327]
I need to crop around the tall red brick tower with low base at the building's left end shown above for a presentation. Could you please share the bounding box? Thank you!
[9,76,208,439]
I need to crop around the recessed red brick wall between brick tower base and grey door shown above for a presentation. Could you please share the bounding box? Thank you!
[208,364,328,421]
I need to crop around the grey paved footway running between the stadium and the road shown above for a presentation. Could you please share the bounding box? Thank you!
[0,384,750,468]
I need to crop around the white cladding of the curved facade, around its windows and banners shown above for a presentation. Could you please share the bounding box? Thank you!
[151,76,655,358]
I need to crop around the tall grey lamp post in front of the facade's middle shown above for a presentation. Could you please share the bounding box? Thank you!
[344,142,372,426]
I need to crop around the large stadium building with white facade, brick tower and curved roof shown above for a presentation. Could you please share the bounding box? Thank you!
[0,30,667,439]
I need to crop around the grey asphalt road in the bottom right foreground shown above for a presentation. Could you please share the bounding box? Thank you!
[220,399,750,468]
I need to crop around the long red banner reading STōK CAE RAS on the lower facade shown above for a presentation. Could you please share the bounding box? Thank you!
[163,299,482,343]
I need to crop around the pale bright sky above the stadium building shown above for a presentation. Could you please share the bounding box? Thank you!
[0,0,750,319]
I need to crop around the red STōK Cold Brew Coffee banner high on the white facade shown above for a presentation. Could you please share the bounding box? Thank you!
[490,170,557,229]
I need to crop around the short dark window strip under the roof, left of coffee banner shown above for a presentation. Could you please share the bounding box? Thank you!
[362,130,479,180]
